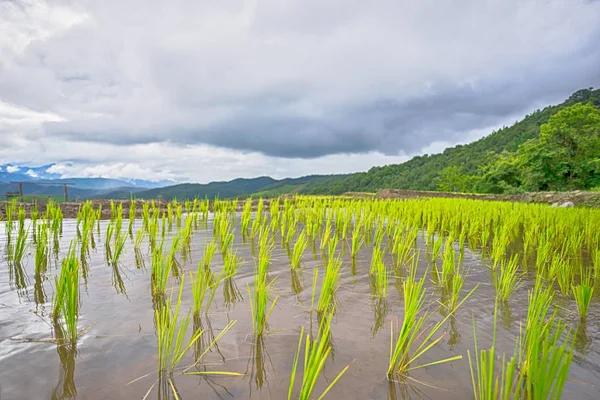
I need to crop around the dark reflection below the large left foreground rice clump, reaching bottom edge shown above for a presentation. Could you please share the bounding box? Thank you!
[51,322,77,400]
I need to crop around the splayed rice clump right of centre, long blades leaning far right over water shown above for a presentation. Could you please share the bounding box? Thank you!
[387,270,475,378]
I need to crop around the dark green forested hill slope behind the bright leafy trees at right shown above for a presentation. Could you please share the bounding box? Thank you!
[305,89,600,194]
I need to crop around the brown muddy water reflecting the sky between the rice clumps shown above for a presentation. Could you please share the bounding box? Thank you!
[0,220,600,400]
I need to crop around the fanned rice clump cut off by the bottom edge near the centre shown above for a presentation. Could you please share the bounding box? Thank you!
[288,315,350,400]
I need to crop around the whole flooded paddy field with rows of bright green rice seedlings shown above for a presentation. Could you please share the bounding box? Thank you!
[0,197,600,400]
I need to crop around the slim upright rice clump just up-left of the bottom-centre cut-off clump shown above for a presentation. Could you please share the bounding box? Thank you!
[248,229,279,335]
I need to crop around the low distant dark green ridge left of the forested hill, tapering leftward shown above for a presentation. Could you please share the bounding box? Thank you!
[102,175,348,200]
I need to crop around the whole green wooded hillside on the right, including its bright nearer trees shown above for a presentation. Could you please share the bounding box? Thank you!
[303,88,600,194]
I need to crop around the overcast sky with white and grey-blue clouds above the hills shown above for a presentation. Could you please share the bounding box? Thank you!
[0,0,600,182]
